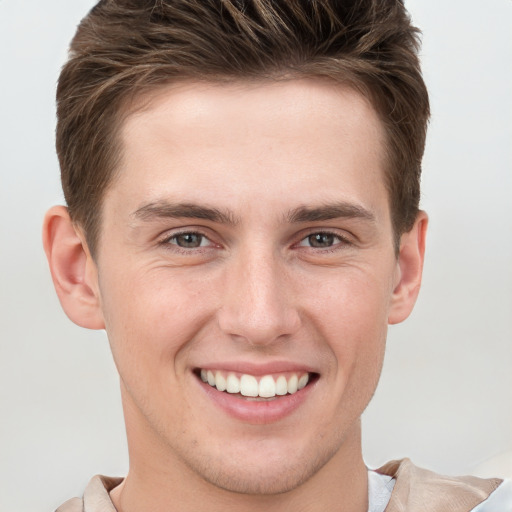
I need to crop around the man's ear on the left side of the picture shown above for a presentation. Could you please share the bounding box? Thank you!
[43,206,105,329]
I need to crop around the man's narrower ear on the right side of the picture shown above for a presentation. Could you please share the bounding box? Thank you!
[388,211,428,324]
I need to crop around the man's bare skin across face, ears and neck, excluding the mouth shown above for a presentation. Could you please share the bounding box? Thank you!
[44,80,427,512]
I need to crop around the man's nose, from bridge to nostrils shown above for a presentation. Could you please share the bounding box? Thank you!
[218,246,301,346]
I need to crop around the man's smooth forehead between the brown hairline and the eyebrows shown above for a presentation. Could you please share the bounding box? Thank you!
[113,79,386,222]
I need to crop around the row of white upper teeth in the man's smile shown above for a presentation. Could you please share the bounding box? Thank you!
[201,370,309,398]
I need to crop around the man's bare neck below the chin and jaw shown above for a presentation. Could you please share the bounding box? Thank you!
[111,388,368,512]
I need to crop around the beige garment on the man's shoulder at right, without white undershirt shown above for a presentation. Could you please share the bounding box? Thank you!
[377,459,512,512]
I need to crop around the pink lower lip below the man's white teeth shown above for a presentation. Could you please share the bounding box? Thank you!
[196,378,316,425]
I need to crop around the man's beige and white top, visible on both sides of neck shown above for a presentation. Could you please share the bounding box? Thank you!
[55,459,512,512]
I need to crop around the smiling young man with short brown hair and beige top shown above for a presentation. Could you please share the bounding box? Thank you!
[44,0,512,512]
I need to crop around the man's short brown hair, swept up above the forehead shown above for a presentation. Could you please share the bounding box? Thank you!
[57,0,429,254]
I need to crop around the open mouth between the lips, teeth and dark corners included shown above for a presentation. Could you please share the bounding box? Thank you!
[195,368,318,401]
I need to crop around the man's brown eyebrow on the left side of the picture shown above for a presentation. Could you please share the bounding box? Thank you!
[132,201,242,225]
